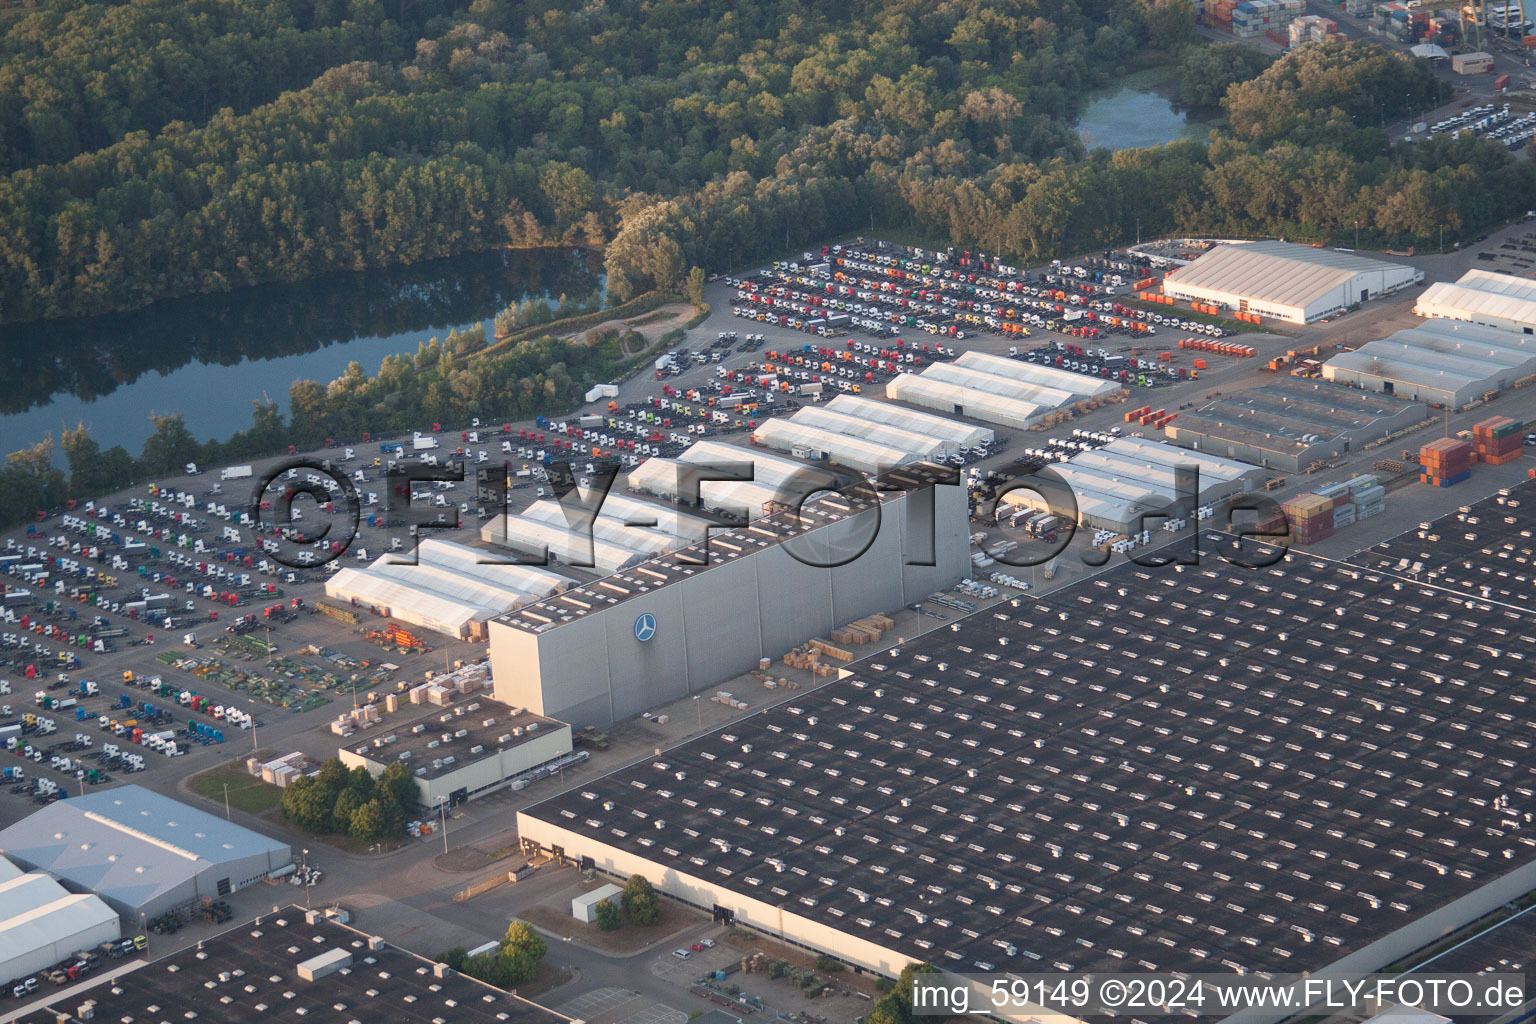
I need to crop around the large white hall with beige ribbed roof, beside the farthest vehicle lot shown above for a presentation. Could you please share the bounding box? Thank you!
[1163,241,1424,324]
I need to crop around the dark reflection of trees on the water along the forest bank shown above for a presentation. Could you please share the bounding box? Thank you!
[0,250,599,415]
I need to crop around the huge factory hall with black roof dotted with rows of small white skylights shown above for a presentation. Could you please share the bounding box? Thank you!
[519,487,1536,973]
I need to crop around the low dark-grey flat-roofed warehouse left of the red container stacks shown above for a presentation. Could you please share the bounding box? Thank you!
[1163,376,1428,473]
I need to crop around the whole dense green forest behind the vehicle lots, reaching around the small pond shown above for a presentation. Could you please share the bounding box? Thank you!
[0,0,1528,321]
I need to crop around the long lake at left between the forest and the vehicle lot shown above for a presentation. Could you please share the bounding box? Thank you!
[0,249,604,454]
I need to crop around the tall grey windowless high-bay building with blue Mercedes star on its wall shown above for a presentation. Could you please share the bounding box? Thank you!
[490,464,971,728]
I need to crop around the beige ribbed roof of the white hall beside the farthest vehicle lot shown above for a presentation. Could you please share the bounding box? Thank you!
[1169,241,1415,309]
